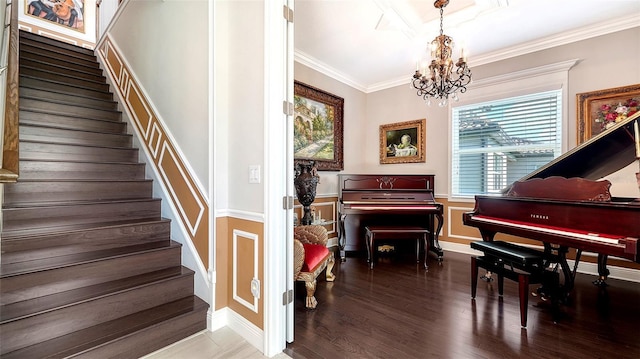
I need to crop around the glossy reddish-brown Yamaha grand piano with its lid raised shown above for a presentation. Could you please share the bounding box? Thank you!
[463,112,640,299]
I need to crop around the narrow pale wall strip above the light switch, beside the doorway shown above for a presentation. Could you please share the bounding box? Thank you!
[221,1,266,213]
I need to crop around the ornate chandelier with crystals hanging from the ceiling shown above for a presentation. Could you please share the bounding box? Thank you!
[411,0,471,107]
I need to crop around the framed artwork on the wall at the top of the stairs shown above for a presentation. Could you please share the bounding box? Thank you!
[24,0,85,34]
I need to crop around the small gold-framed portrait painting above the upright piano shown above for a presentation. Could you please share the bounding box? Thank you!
[380,119,427,164]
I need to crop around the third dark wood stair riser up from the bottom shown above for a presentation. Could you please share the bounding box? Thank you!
[0,246,181,306]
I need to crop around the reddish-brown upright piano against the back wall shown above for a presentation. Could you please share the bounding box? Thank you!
[338,174,443,260]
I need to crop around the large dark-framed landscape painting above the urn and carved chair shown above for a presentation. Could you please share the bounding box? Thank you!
[293,81,344,171]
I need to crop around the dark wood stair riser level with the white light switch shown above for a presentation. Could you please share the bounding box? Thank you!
[20,161,145,181]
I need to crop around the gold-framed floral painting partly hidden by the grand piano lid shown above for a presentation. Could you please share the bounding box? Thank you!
[576,84,640,145]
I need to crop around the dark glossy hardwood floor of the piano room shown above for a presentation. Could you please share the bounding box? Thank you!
[285,252,640,359]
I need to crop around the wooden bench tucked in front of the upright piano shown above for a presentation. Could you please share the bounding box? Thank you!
[364,226,429,269]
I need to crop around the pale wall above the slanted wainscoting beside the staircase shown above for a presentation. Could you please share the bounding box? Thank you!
[110,0,210,192]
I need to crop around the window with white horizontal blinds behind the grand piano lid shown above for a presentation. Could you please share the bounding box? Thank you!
[451,90,562,197]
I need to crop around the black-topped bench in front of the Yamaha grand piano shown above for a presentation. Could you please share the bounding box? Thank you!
[471,241,544,328]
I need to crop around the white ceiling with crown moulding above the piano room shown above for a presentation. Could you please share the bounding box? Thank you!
[294,0,640,92]
